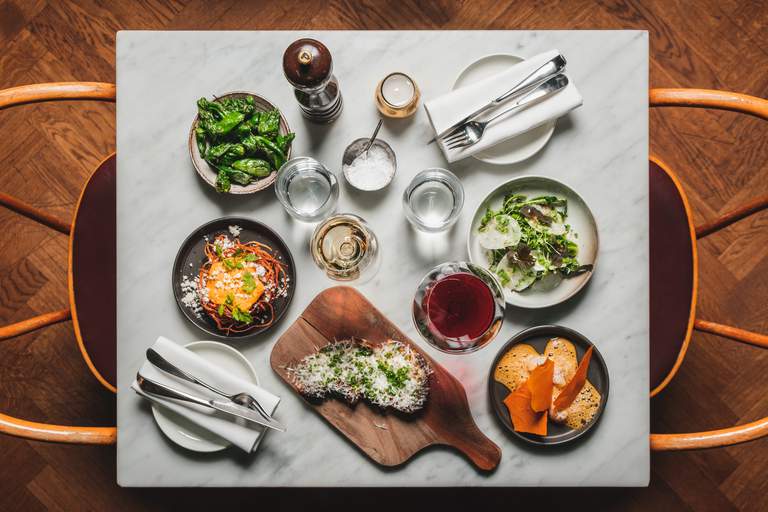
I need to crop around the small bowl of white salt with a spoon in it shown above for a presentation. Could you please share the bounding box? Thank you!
[341,137,397,191]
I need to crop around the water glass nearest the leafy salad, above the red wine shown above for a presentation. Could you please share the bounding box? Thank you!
[403,168,464,233]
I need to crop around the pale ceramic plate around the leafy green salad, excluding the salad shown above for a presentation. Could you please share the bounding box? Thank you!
[467,176,599,309]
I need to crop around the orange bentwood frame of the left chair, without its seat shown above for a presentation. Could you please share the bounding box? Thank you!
[0,82,117,444]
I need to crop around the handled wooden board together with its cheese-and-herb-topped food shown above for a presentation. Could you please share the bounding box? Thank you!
[270,286,501,470]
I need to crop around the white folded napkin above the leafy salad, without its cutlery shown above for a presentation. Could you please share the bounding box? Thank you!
[424,50,583,162]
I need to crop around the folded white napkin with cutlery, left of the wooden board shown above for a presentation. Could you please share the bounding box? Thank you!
[131,336,285,453]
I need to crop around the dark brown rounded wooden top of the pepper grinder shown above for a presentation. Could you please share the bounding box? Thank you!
[283,38,333,88]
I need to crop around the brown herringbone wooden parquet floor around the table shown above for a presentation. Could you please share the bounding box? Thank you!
[0,0,768,511]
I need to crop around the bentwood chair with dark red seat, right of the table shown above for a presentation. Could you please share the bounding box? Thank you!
[649,89,768,450]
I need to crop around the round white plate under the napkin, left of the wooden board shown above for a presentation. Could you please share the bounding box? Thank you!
[152,341,259,453]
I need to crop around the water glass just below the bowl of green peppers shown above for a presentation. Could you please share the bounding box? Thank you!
[275,156,339,222]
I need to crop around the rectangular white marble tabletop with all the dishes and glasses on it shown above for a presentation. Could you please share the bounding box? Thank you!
[116,31,649,487]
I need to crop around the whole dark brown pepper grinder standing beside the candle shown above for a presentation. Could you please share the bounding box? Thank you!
[283,39,343,123]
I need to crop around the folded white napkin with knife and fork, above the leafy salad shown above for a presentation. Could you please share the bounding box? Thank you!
[424,50,583,162]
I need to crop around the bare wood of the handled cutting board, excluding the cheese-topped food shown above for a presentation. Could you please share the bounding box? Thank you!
[270,286,501,471]
